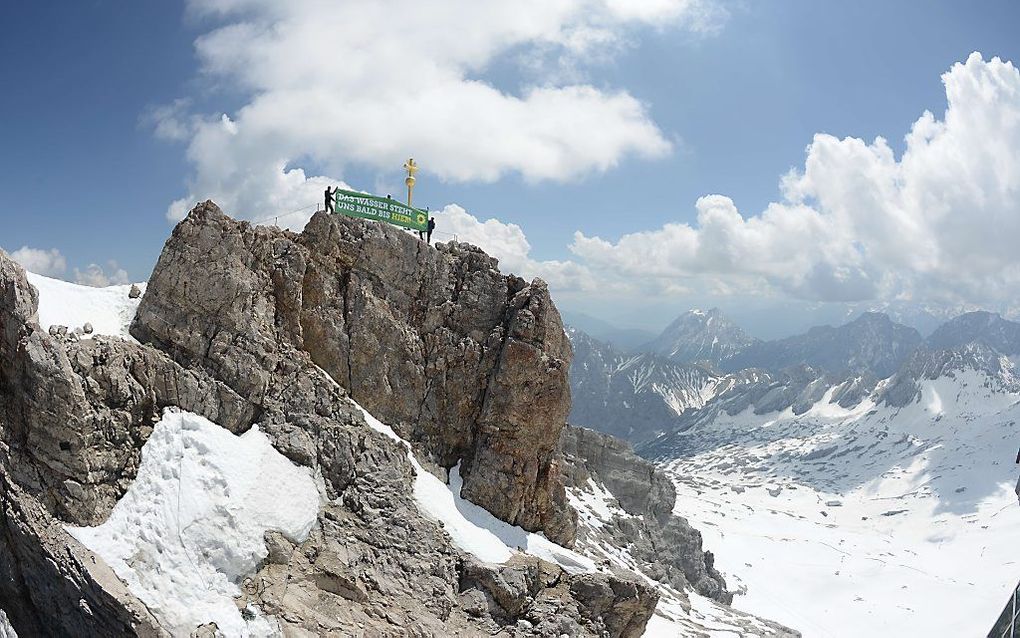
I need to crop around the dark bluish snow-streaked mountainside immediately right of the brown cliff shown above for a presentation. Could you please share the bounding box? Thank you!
[567,327,720,442]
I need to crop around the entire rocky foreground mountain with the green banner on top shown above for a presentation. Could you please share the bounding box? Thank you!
[0,202,794,637]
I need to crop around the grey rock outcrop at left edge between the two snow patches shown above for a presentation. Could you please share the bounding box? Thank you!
[0,326,253,525]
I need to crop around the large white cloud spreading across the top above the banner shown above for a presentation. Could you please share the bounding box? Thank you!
[159,0,725,219]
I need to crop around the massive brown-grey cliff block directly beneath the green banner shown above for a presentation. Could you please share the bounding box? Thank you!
[132,202,575,544]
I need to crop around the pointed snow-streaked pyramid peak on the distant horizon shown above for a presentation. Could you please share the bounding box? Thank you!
[641,308,758,365]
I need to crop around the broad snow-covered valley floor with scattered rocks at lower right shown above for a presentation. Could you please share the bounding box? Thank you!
[663,372,1020,638]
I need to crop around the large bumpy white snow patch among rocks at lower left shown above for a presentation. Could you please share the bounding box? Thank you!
[67,409,320,636]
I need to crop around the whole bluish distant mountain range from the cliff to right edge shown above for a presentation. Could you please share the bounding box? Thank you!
[568,308,1020,443]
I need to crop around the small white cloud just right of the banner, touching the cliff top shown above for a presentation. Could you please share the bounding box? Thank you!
[434,204,595,291]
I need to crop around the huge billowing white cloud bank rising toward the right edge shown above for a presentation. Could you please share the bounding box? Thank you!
[570,53,1020,303]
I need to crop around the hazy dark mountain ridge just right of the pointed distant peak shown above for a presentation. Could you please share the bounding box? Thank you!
[722,312,921,379]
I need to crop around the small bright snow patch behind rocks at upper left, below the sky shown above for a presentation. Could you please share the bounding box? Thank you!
[27,273,145,339]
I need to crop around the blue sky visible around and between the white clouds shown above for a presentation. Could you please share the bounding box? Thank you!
[0,0,1020,333]
